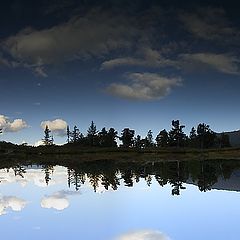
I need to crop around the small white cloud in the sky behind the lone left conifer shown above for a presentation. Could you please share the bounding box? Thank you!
[41,119,67,136]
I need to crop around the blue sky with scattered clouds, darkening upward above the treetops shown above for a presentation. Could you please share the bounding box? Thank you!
[0,0,240,144]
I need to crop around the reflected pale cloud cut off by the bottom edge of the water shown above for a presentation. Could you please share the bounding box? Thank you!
[116,230,170,240]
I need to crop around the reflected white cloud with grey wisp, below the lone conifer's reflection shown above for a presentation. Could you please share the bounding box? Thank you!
[41,191,79,211]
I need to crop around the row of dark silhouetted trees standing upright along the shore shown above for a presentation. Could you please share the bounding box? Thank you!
[42,120,231,149]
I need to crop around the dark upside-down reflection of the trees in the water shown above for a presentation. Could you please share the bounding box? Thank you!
[1,160,240,195]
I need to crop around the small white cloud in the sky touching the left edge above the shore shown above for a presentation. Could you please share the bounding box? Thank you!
[0,115,28,132]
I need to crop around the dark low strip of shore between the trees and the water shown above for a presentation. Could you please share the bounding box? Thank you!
[0,146,240,168]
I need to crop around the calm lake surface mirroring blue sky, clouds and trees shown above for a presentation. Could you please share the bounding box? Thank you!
[0,160,240,240]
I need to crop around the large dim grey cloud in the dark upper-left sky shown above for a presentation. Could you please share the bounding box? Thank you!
[1,9,139,73]
